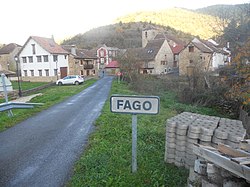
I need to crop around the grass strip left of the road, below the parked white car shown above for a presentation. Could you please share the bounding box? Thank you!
[0,79,96,131]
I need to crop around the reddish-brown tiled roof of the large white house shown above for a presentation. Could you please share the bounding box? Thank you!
[20,36,68,54]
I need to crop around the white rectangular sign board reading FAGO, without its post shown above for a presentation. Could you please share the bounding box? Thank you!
[110,95,160,114]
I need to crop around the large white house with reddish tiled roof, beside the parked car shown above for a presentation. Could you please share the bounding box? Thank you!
[18,36,69,82]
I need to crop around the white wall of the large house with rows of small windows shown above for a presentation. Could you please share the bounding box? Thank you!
[19,39,69,81]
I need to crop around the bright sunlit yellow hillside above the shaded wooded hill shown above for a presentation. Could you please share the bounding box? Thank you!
[116,8,222,39]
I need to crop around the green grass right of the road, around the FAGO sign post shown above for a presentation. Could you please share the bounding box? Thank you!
[68,82,188,187]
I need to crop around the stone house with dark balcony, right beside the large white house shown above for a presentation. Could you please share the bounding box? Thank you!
[62,45,99,76]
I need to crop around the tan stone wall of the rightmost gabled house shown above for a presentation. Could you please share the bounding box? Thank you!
[179,44,212,75]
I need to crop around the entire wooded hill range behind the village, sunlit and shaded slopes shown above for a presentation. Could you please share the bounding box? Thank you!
[62,4,250,48]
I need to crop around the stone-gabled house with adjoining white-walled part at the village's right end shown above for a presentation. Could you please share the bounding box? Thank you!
[179,38,228,75]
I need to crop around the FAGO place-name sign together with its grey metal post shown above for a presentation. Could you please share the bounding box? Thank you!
[110,95,160,173]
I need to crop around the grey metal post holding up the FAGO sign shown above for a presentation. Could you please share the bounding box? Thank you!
[132,114,137,173]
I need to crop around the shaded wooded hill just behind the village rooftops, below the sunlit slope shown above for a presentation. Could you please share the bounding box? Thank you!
[62,22,192,49]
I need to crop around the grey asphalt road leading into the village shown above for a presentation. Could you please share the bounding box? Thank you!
[0,76,112,187]
